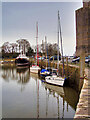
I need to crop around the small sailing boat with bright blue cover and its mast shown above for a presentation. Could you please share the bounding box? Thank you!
[40,36,51,77]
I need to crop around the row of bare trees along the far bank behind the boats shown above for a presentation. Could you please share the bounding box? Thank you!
[1,39,60,58]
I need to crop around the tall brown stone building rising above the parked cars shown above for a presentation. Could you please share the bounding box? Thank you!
[76,0,90,56]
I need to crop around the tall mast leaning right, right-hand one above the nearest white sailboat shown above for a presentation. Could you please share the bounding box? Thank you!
[58,11,65,76]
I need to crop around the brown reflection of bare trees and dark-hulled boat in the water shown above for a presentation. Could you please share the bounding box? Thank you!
[2,66,30,84]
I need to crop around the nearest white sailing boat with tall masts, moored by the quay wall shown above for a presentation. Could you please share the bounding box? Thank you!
[45,11,66,86]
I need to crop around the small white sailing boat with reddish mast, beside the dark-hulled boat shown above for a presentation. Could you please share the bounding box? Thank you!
[30,22,41,74]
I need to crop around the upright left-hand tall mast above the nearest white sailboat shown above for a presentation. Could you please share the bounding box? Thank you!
[57,11,59,75]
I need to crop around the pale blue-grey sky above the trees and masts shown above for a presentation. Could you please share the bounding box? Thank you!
[1,2,82,55]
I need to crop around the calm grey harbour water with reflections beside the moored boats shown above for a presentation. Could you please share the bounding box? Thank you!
[0,65,78,118]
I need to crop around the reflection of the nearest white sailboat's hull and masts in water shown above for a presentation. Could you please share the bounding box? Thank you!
[45,84,65,118]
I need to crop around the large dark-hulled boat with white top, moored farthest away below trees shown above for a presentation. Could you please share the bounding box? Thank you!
[15,54,30,66]
